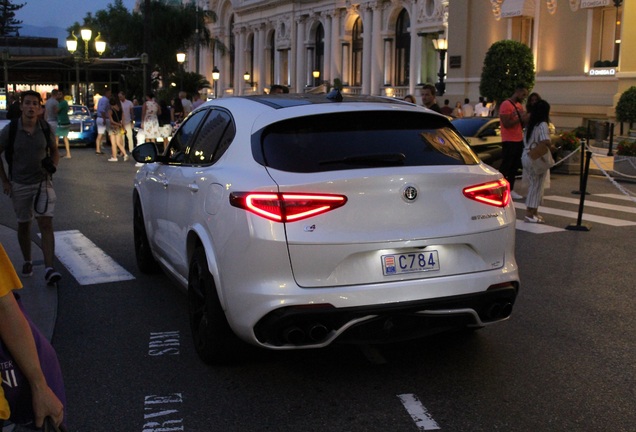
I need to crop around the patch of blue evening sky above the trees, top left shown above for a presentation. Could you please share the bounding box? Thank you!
[12,0,135,30]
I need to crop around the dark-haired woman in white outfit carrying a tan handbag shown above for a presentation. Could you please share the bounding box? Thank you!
[521,100,556,223]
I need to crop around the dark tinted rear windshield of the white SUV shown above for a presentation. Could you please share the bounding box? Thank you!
[253,111,479,173]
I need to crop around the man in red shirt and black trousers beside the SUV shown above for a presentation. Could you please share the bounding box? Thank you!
[499,84,528,199]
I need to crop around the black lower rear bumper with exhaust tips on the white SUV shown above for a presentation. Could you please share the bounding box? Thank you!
[254,282,518,349]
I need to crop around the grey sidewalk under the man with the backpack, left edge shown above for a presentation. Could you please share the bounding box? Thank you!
[0,225,57,341]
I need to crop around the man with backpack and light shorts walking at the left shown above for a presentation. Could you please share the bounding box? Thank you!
[0,90,62,285]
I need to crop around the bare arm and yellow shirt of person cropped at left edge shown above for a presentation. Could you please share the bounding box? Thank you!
[0,244,64,428]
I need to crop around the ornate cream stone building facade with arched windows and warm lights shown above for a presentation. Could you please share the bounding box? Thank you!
[186,0,636,127]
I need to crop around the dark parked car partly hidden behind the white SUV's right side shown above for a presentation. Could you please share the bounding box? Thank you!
[451,117,502,168]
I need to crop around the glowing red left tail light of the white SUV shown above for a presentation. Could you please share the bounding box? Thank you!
[230,192,347,222]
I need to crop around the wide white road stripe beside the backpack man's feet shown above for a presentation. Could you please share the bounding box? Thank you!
[55,230,135,285]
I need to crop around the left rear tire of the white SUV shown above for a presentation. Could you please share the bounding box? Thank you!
[188,246,247,364]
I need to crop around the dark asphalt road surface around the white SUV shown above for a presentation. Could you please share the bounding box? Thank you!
[0,148,636,432]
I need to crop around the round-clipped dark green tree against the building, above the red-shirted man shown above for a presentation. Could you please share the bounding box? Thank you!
[479,40,535,109]
